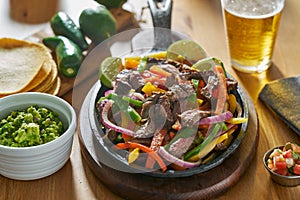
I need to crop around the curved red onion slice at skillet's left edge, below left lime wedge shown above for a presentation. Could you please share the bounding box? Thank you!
[101,100,135,136]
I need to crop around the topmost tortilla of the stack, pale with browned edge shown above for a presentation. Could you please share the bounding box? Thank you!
[0,38,48,94]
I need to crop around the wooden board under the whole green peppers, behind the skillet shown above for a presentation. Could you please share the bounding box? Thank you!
[25,8,139,96]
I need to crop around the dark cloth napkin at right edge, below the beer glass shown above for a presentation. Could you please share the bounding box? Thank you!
[259,76,300,136]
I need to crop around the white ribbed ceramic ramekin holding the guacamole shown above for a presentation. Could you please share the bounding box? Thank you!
[0,92,76,180]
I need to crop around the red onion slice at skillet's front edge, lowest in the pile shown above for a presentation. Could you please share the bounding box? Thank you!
[158,146,201,168]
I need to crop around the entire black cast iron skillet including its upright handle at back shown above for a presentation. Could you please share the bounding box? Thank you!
[82,0,249,178]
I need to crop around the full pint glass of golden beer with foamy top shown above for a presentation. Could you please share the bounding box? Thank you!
[221,0,284,73]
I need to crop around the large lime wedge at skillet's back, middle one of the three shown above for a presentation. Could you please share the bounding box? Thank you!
[167,40,207,64]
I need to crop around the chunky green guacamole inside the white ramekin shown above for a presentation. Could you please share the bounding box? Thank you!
[0,105,64,147]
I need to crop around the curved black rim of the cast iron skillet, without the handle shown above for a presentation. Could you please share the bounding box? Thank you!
[88,73,249,178]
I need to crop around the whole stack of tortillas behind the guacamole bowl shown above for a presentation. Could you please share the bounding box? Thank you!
[0,38,61,98]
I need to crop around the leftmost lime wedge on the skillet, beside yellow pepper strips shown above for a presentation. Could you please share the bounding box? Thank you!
[99,57,123,88]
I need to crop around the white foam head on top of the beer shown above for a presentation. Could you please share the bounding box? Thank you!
[222,0,284,19]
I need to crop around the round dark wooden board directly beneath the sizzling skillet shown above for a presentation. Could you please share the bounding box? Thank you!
[78,82,259,200]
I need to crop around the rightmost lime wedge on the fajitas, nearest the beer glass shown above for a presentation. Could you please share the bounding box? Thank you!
[192,57,227,77]
